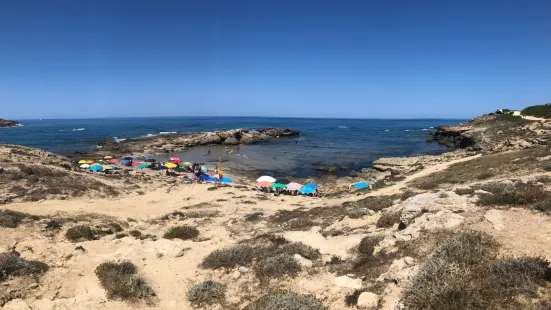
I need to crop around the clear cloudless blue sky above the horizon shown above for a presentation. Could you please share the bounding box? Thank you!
[0,0,551,119]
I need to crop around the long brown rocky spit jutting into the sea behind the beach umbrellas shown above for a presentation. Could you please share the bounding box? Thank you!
[88,128,301,155]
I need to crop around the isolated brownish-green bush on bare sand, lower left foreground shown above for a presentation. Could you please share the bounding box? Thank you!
[95,261,155,300]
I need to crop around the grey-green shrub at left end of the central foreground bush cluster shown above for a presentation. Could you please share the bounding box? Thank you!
[201,245,255,269]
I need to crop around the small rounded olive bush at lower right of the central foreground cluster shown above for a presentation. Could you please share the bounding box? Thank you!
[253,253,300,281]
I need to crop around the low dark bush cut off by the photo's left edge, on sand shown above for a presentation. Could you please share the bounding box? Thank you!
[0,252,49,282]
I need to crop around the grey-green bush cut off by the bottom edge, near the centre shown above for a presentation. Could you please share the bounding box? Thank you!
[245,291,326,310]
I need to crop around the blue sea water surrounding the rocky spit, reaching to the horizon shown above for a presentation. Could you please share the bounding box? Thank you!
[0,117,463,177]
